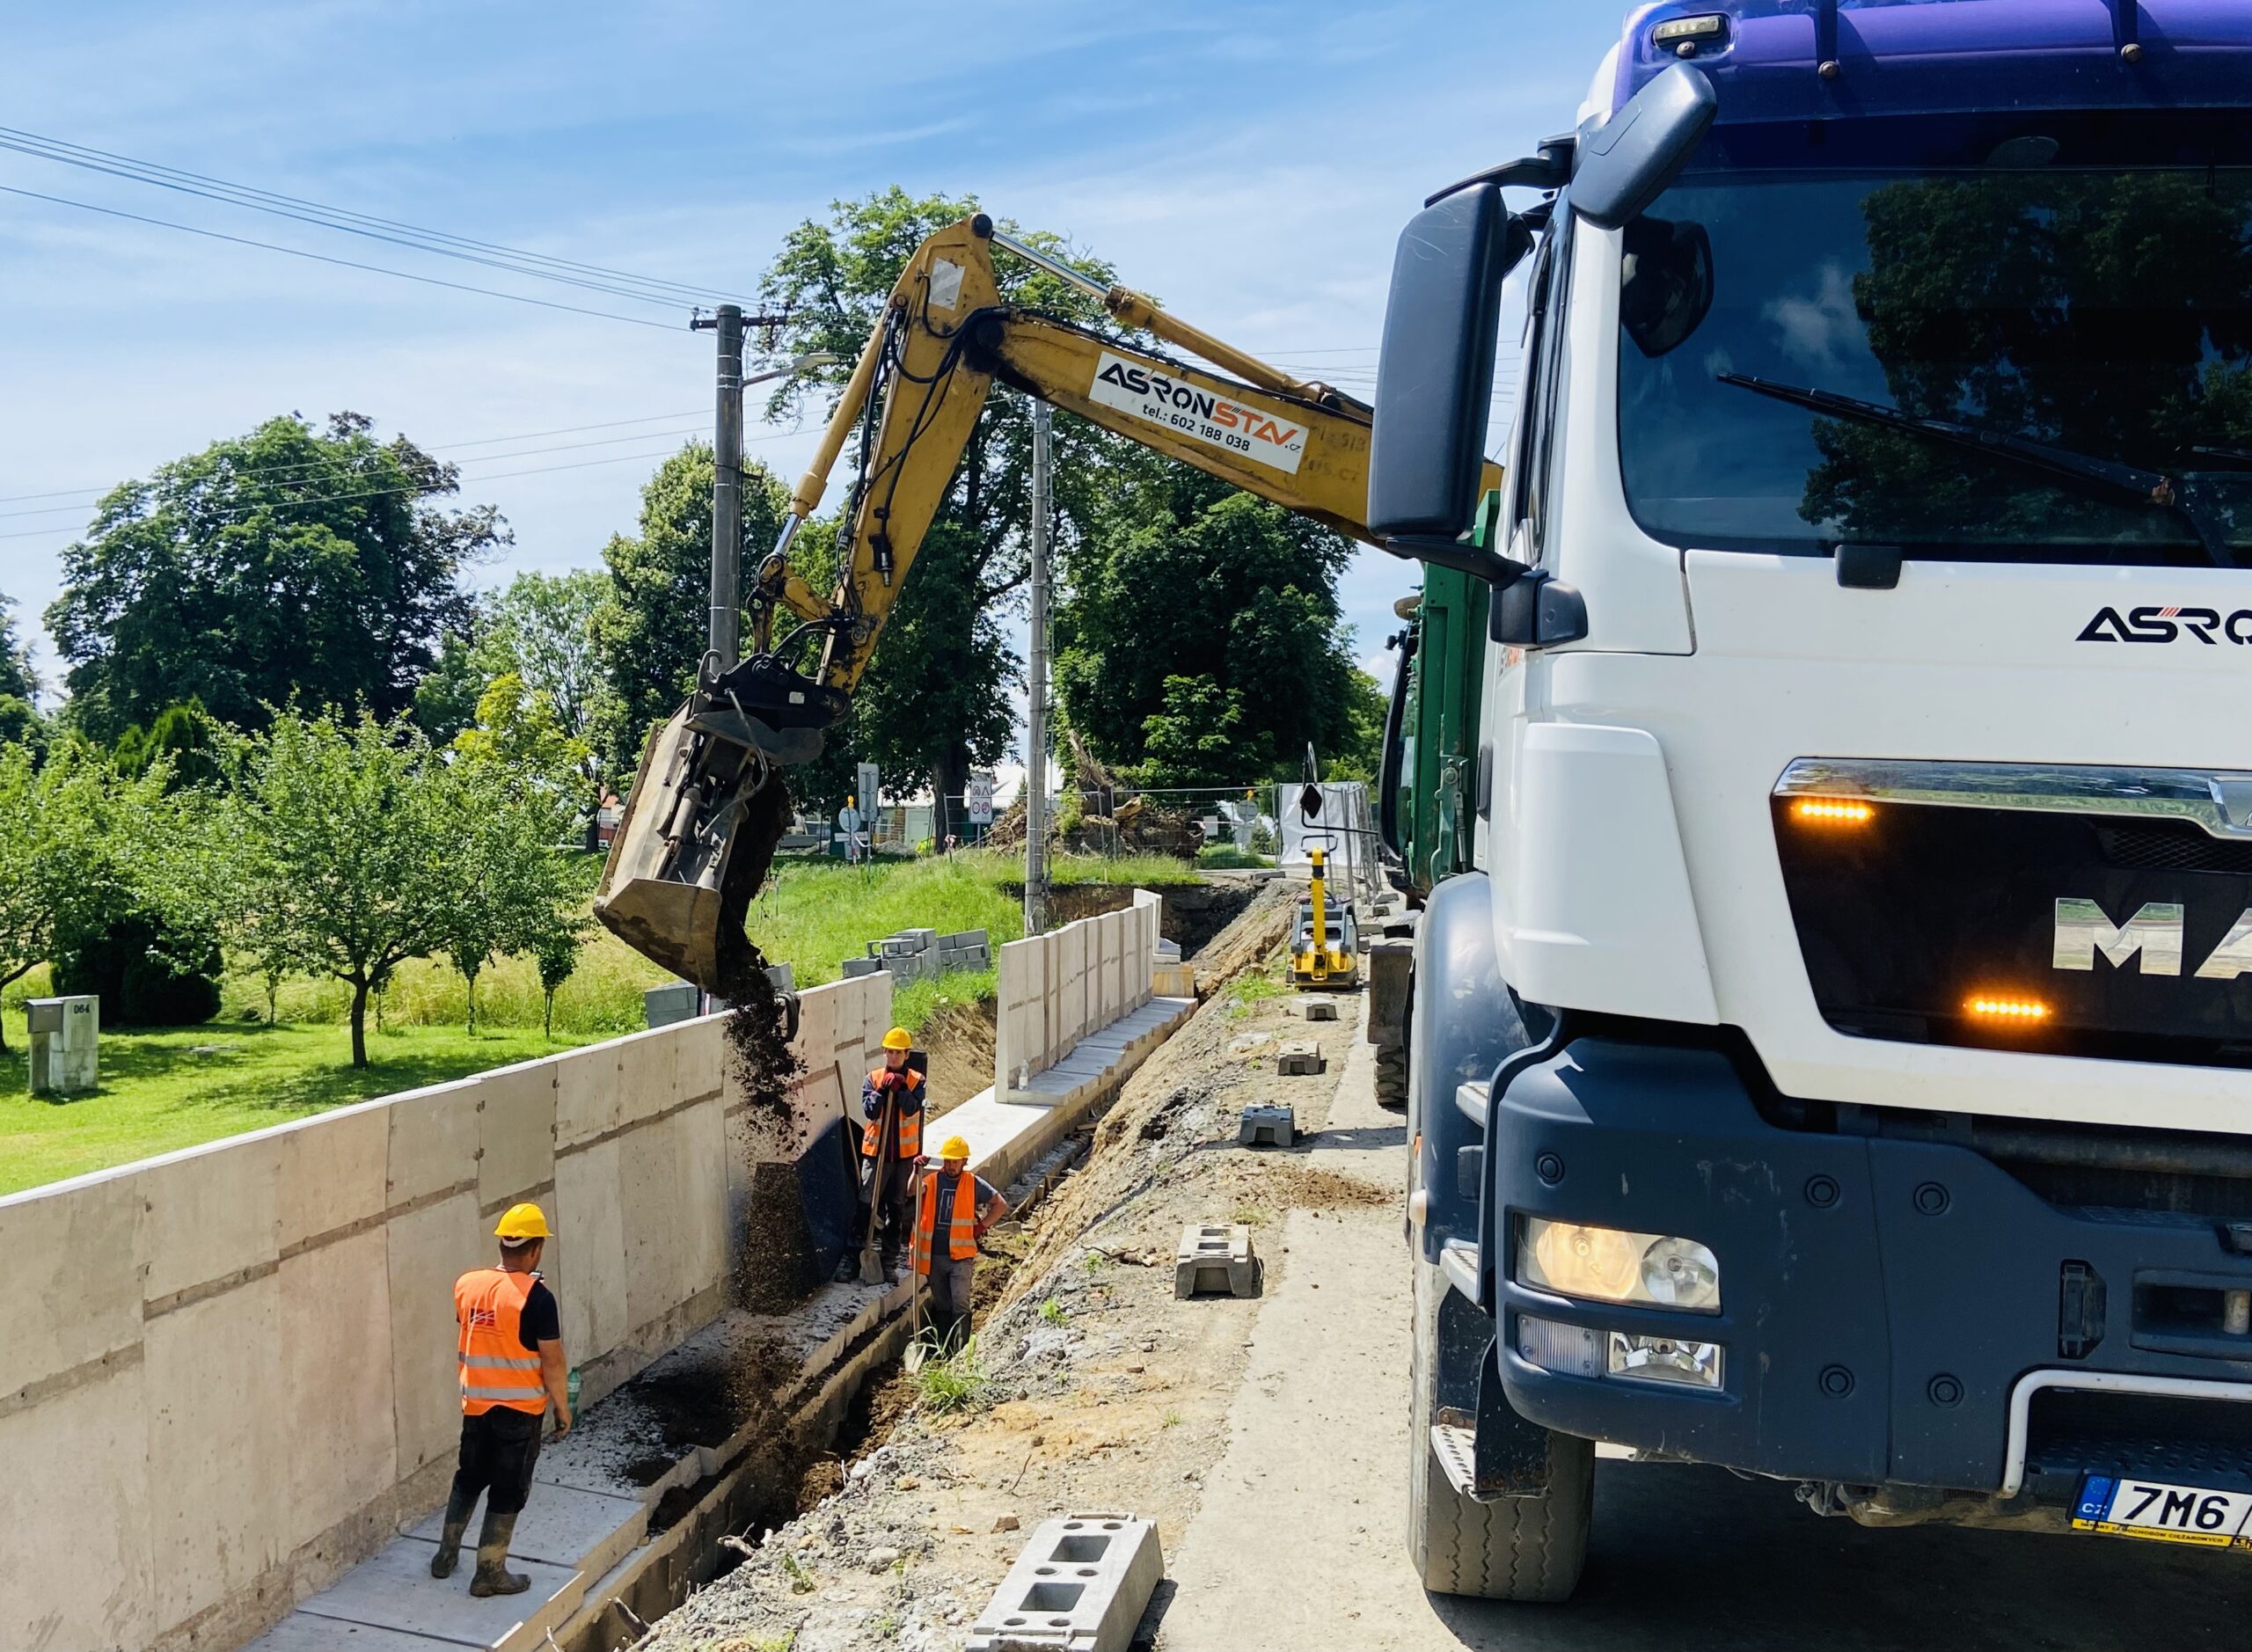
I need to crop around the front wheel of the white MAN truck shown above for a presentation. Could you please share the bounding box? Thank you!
[1408,1258,1594,1600]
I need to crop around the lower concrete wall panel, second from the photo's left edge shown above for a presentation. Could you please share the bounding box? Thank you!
[144,1274,282,1625]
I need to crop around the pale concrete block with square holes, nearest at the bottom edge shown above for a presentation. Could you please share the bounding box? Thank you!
[966,1515,1165,1652]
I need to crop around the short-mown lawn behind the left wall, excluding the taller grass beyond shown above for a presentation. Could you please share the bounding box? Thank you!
[0,1022,595,1193]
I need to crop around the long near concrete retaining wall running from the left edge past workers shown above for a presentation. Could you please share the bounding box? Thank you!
[0,972,896,1652]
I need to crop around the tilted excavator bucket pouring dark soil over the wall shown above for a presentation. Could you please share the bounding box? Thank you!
[595,657,844,999]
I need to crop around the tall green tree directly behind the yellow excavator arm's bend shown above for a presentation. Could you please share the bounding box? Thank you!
[761,186,1123,828]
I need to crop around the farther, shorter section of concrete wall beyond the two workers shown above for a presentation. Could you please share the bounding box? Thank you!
[993,889,1162,1096]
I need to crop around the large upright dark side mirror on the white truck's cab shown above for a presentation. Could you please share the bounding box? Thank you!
[1369,182,1533,581]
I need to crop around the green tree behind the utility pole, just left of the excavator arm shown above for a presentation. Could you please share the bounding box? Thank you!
[586,441,791,774]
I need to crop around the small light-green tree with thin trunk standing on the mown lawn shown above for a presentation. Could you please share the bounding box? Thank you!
[225,712,459,1067]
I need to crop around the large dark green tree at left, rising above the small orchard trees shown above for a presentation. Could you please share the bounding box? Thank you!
[48,414,507,742]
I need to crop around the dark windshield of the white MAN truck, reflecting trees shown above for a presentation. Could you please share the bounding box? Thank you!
[1620,169,2252,565]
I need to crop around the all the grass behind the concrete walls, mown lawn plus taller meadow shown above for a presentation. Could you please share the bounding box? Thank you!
[0,851,1195,1193]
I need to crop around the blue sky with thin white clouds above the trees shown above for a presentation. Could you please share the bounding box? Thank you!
[0,0,1624,724]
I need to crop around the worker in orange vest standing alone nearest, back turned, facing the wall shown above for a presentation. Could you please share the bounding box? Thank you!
[430,1204,572,1596]
